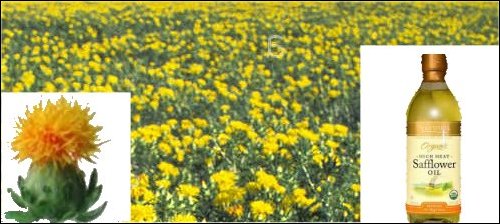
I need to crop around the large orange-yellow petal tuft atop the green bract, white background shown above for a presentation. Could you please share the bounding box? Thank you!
[12,97,103,165]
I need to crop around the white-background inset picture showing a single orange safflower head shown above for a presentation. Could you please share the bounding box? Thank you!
[0,93,130,223]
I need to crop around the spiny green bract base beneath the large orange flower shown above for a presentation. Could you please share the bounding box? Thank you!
[5,163,107,222]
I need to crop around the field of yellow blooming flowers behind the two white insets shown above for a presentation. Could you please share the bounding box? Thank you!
[1,2,498,222]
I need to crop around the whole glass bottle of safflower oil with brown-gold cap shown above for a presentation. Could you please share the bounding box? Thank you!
[406,54,461,223]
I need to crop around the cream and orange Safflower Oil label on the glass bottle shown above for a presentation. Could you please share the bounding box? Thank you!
[406,122,461,214]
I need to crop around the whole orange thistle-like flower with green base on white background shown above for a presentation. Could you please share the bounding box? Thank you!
[5,97,107,222]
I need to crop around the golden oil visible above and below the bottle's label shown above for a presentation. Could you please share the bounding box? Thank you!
[407,82,462,223]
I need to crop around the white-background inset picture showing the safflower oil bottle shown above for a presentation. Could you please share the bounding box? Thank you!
[361,46,499,223]
